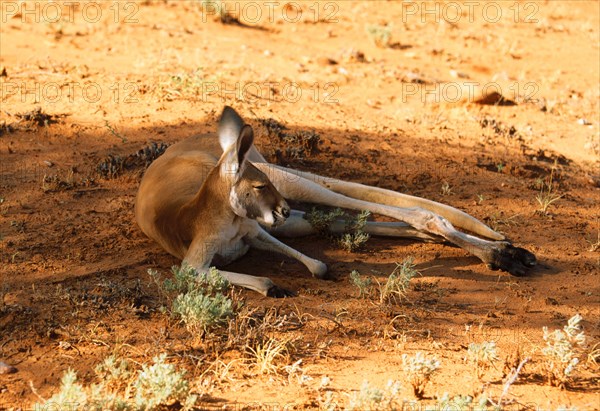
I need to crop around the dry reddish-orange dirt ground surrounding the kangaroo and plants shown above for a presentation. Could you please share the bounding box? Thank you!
[0,1,600,410]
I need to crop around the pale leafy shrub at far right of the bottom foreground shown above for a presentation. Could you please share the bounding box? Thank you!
[542,314,585,387]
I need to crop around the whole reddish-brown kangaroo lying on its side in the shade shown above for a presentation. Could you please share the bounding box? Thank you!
[135,107,535,296]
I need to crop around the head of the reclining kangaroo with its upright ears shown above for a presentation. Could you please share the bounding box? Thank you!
[217,107,290,226]
